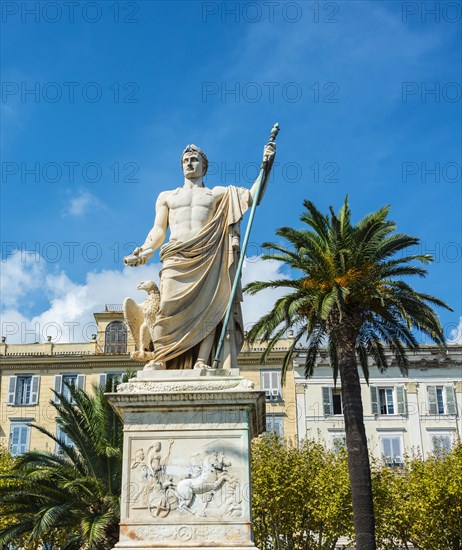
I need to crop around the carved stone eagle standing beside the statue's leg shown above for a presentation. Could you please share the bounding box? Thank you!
[123,281,160,361]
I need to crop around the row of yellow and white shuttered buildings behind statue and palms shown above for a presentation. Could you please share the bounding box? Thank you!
[0,305,462,465]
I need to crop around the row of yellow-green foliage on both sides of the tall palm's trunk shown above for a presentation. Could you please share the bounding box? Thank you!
[252,440,462,550]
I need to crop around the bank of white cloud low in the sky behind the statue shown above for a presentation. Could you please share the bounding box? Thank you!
[1,253,286,343]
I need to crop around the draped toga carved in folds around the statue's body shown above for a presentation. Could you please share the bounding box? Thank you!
[154,186,251,369]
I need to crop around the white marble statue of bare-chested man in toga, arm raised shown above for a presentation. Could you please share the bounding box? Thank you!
[124,142,276,369]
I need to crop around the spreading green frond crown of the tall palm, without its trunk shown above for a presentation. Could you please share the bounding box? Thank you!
[246,201,450,398]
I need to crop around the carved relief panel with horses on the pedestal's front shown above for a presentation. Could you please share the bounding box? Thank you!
[124,434,248,524]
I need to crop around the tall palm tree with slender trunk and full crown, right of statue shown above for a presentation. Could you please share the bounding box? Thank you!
[245,197,450,550]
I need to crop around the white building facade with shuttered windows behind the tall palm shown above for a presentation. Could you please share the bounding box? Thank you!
[294,346,462,465]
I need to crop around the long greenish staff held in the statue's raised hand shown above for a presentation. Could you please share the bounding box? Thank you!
[212,122,279,369]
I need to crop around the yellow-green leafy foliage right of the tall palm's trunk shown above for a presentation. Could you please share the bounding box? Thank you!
[372,443,462,550]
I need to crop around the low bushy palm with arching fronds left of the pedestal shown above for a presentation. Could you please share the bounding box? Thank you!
[0,381,123,550]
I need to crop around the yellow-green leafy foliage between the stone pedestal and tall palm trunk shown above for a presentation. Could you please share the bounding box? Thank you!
[252,434,353,550]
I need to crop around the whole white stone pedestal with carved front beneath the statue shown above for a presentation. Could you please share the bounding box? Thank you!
[108,370,265,550]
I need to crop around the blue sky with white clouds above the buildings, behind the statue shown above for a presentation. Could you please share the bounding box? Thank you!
[1,0,462,341]
